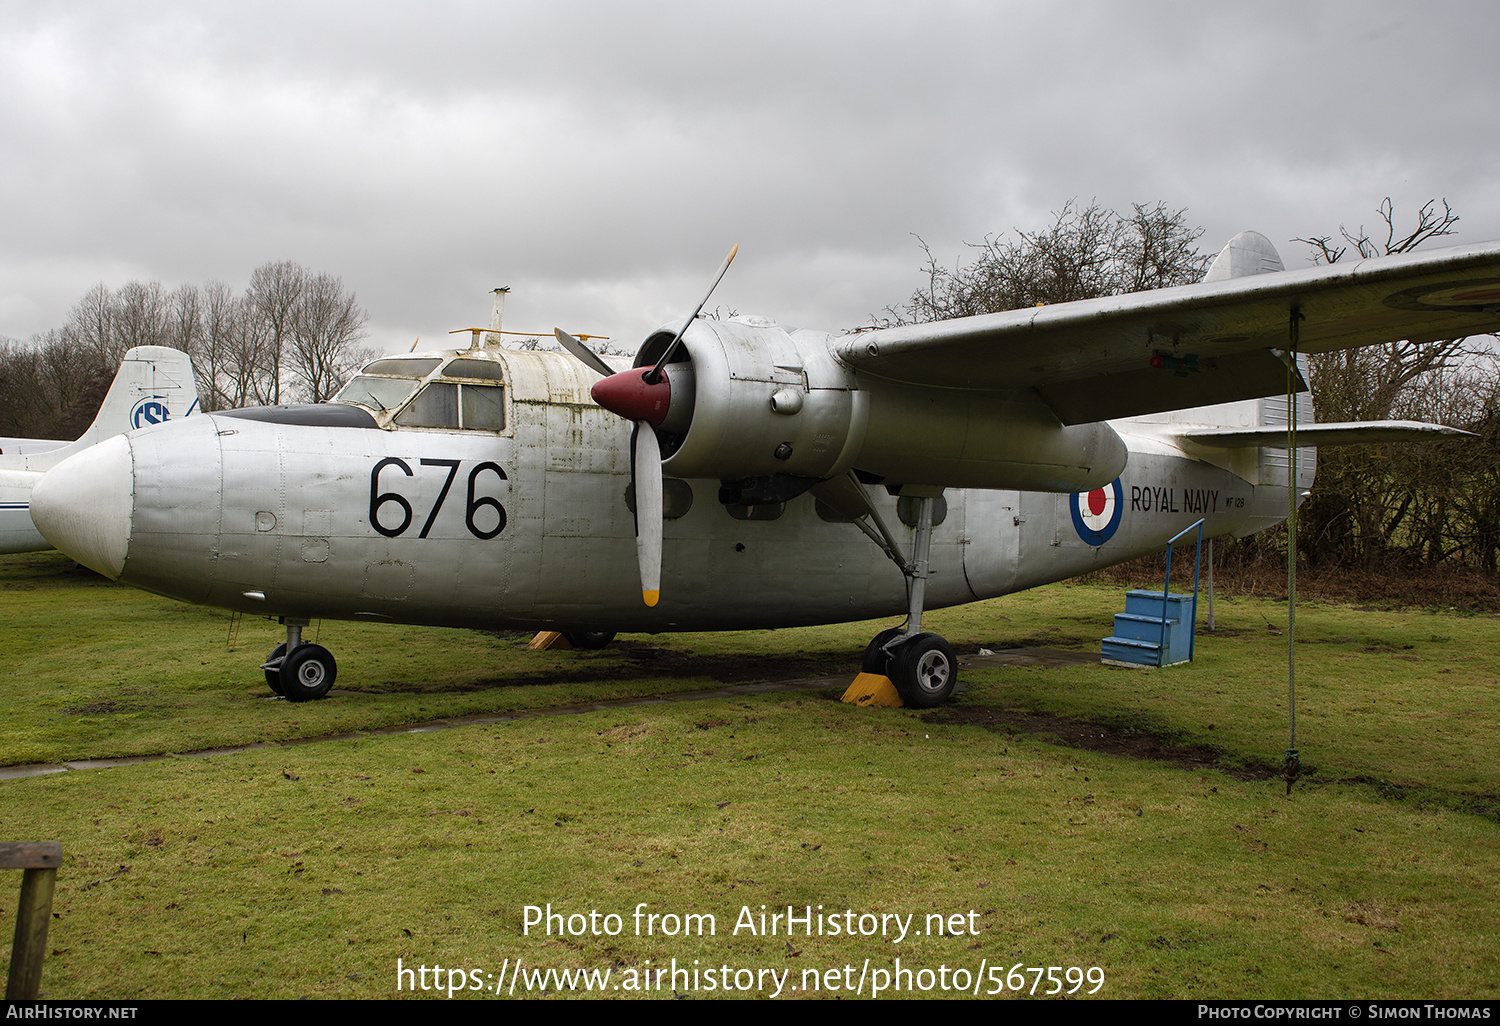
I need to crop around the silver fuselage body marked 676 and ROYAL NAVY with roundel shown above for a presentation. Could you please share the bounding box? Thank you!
[35,353,1286,632]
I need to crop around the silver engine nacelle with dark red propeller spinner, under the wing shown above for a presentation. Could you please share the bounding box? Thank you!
[609,318,1128,504]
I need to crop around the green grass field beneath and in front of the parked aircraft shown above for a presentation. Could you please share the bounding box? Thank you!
[0,555,1500,999]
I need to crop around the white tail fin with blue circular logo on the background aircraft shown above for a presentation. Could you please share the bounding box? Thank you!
[24,345,198,471]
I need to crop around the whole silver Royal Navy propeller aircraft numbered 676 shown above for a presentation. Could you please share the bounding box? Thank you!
[20,233,1500,705]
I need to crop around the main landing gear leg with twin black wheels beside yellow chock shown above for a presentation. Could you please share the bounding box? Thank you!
[863,495,959,708]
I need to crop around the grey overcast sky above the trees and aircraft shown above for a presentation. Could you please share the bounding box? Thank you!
[0,0,1500,350]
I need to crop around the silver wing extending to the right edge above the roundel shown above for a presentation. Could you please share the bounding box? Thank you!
[836,243,1500,425]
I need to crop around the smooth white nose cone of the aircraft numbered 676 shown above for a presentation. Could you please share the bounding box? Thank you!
[32,435,135,579]
